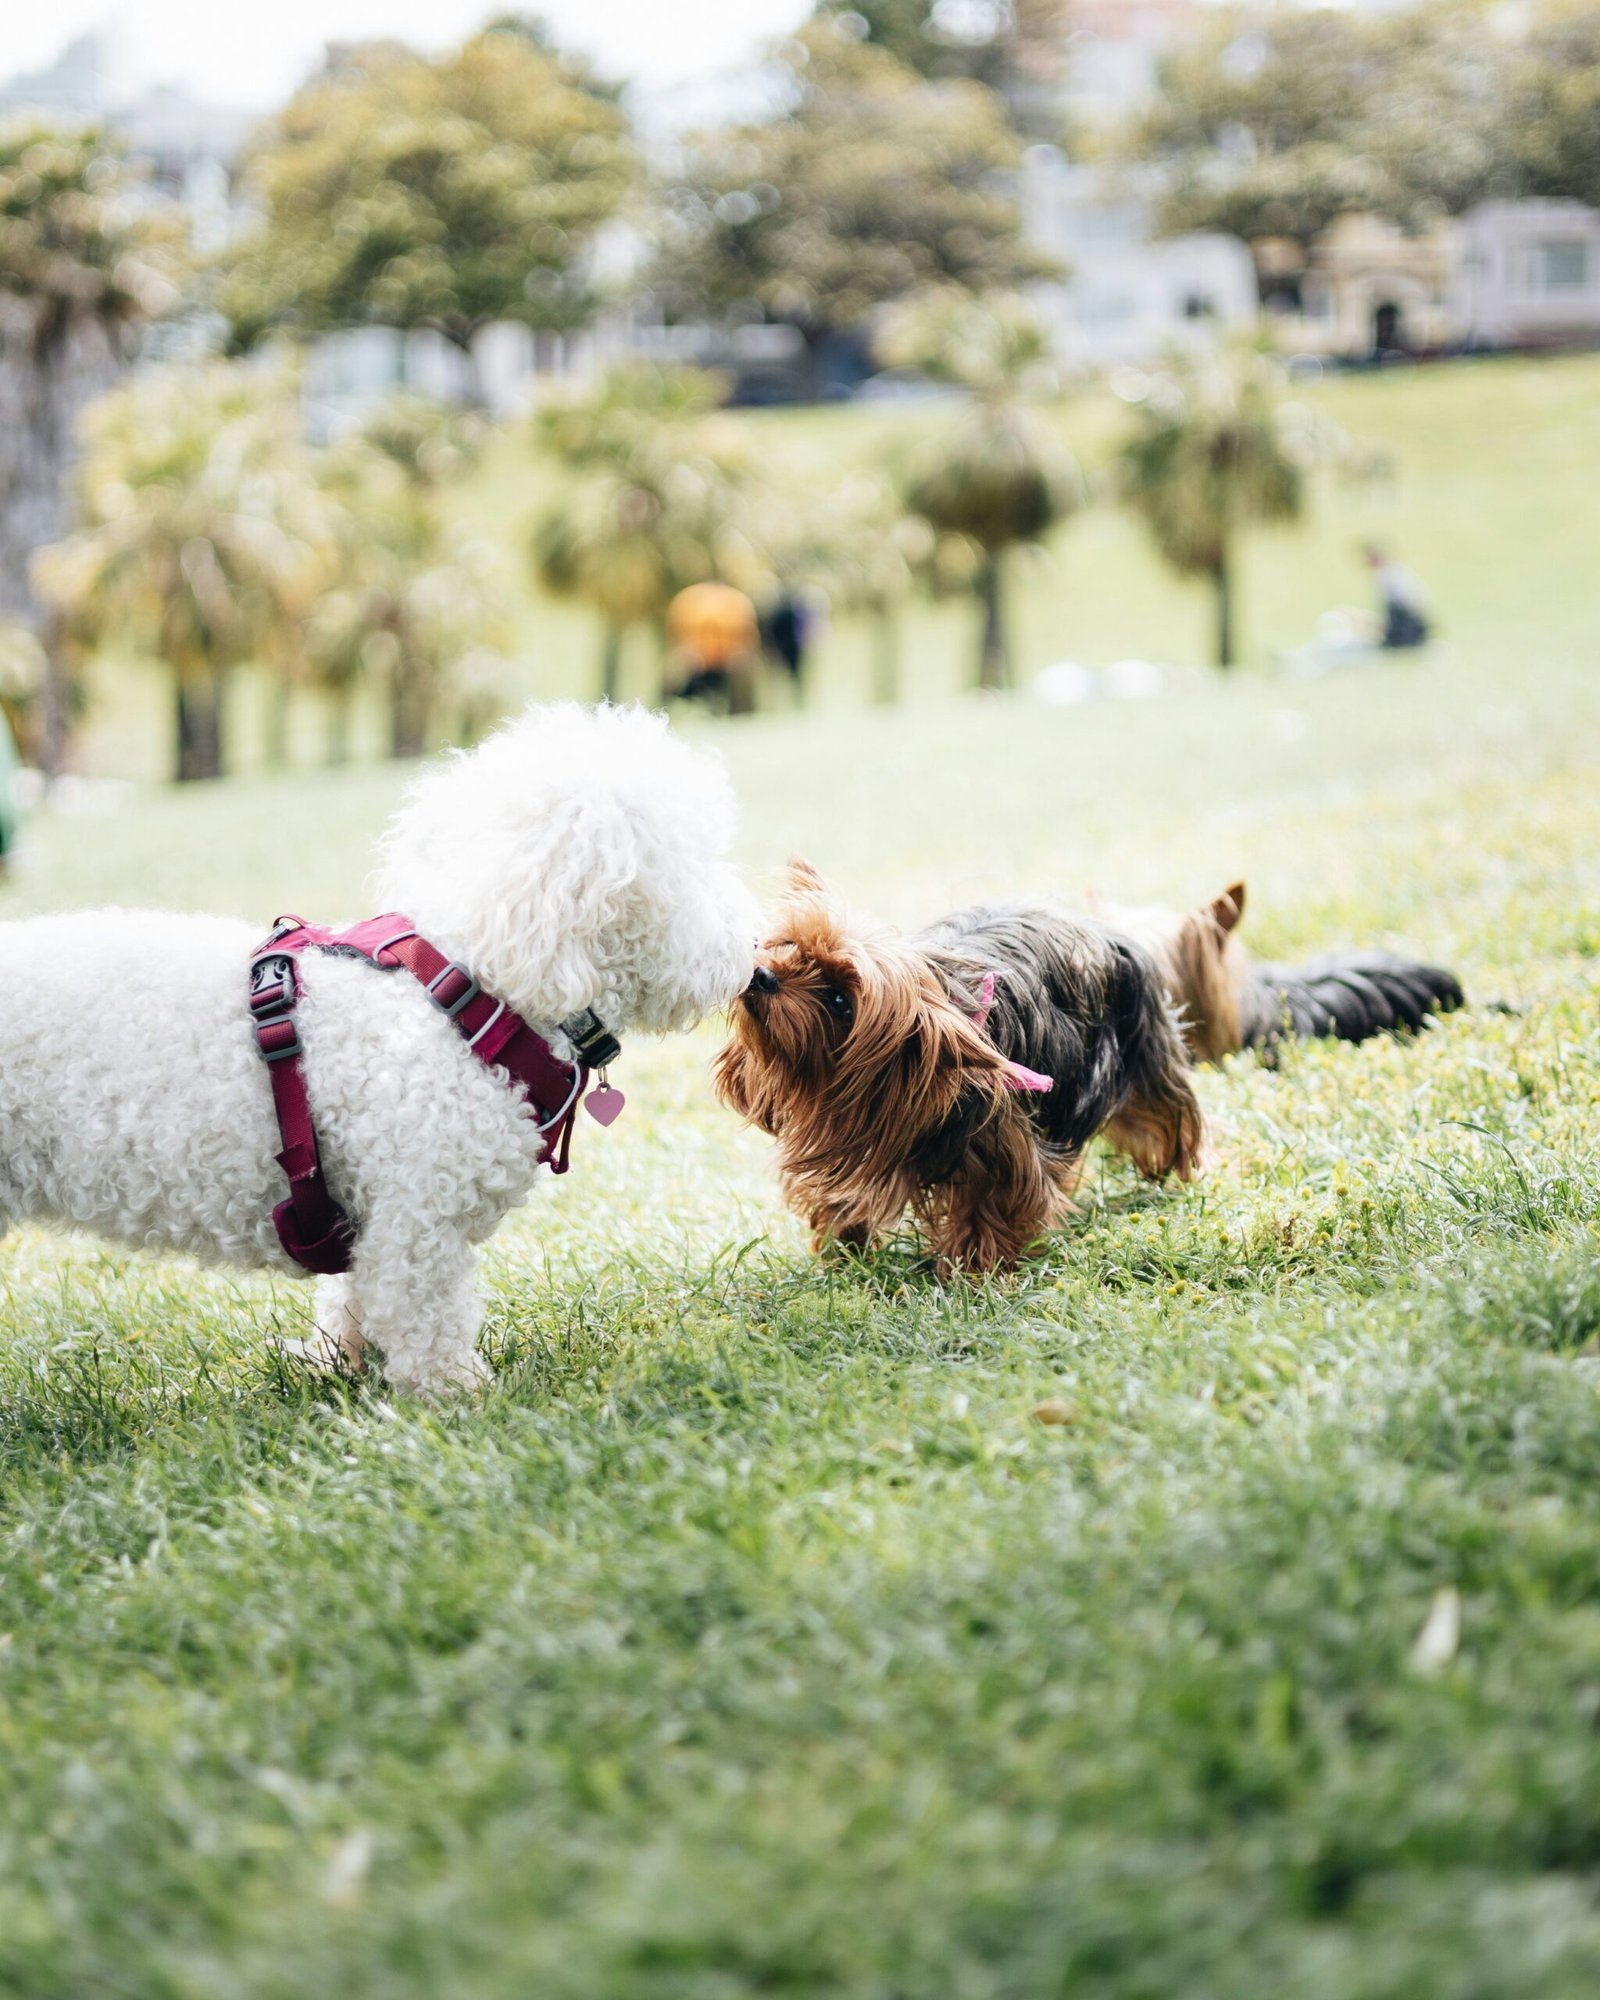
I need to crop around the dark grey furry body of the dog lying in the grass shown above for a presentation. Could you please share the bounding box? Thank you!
[1238,952,1466,1048]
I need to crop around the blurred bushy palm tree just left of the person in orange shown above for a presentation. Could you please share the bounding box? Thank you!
[532,364,760,700]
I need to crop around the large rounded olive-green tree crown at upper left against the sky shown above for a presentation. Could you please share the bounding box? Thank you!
[222,20,634,394]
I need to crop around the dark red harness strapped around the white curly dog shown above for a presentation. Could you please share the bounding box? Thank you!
[250,912,620,1274]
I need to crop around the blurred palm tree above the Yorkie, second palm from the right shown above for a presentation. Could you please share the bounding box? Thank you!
[878,292,1082,688]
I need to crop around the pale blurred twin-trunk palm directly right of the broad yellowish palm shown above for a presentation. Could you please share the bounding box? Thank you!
[308,396,506,762]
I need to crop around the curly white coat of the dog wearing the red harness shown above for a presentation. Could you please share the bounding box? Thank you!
[0,704,758,1390]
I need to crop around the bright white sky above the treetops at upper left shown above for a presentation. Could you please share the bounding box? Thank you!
[0,0,810,110]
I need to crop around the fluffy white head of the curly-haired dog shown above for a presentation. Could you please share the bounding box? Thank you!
[378,702,760,1032]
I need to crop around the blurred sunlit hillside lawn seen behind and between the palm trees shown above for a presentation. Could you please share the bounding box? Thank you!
[69,356,1600,778]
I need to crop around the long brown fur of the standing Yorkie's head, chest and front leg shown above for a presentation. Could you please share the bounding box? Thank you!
[714,862,1056,1268]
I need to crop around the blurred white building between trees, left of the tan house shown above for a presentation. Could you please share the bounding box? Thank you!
[1022,146,1258,368]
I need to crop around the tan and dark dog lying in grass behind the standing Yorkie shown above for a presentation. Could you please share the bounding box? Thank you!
[1110,882,1464,1062]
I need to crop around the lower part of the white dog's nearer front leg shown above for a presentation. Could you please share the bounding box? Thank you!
[342,1224,490,1396]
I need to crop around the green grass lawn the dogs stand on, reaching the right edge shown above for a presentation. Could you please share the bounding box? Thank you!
[0,362,1600,2000]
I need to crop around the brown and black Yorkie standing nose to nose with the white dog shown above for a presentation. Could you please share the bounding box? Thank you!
[716,862,1204,1270]
